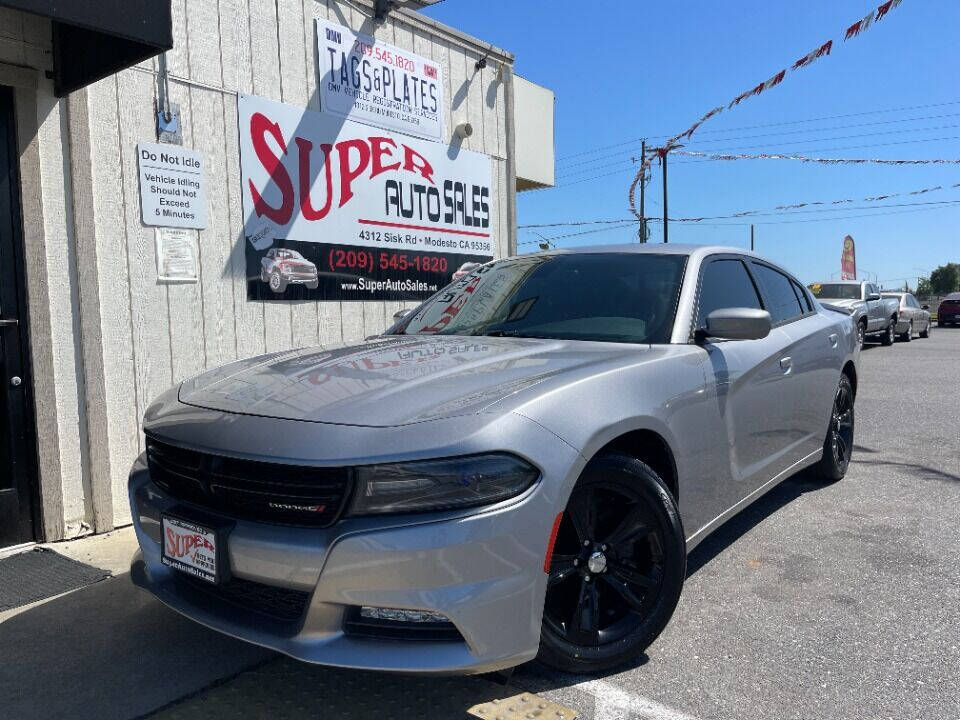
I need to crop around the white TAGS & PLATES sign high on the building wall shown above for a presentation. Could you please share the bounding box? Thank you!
[316,18,444,140]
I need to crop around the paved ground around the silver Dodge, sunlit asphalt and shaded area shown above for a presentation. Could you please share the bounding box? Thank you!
[0,328,960,720]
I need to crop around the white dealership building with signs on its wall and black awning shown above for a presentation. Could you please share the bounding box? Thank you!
[0,0,553,547]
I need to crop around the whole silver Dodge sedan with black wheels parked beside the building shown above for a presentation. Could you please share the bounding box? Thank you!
[129,245,859,673]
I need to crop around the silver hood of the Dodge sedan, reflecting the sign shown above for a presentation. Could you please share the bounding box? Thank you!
[178,335,651,427]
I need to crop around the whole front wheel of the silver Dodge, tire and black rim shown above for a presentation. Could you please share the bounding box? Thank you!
[538,453,687,673]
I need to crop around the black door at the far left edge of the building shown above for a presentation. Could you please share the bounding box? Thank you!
[0,87,36,547]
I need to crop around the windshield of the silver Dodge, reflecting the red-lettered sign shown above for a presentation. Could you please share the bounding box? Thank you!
[392,253,687,343]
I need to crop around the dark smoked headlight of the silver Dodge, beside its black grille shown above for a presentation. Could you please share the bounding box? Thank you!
[349,453,540,515]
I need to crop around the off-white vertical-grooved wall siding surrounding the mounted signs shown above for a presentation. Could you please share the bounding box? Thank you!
[11,0,510,533]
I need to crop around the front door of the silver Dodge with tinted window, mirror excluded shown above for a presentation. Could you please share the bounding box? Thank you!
[696,255,791,515]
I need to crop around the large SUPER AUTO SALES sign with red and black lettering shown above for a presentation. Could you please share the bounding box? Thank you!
[237,95,496,300]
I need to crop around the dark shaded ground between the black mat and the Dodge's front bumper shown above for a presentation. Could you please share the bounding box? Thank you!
[0,573,272,720]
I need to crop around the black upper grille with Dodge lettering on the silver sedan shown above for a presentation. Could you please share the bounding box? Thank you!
[147,437,352,527]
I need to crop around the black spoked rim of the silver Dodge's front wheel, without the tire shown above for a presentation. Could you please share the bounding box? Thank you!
[543,484,665,647]
